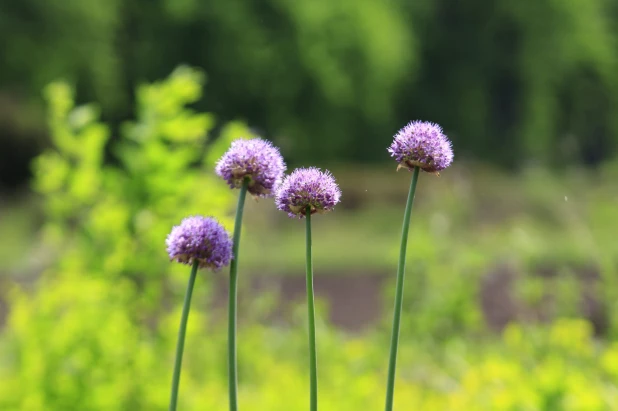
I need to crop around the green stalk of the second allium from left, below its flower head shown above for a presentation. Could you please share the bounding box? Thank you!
[227,179,249,411]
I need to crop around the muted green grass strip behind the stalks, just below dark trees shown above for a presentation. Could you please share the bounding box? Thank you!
[238,167,618,275]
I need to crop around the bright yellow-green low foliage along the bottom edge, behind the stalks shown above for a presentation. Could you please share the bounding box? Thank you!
[0,284,618,411]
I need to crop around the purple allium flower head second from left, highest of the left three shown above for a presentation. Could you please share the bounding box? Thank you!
[215,138,286,197]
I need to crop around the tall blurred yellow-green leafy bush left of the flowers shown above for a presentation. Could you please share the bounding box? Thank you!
[0,67,250,410]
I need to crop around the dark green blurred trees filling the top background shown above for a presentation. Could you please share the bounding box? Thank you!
[0,0,618,177]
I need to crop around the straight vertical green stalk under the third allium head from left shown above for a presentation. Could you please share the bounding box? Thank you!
[305,207,318,411]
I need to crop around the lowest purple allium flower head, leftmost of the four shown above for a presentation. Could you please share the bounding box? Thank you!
[165,216,232,270]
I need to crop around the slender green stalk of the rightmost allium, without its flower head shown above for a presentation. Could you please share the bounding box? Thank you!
[385,167,420,411]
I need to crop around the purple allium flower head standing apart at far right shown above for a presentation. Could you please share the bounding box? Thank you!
[388,121,453,174]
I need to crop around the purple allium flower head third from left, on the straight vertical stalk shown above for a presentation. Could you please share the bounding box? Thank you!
[275,167,341,218]
